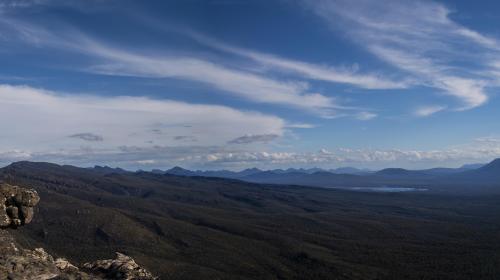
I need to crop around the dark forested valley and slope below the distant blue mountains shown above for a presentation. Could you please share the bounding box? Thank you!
[1,162,500,280]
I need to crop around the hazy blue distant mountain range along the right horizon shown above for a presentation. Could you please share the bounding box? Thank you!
[156,159,500,188]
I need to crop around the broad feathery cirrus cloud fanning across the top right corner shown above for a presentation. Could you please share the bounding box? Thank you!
[306,0,500,110]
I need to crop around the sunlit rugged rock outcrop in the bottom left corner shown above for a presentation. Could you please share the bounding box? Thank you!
[0,183,158,280]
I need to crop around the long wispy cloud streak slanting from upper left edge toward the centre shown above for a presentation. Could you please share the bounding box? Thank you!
[0,18,356,118]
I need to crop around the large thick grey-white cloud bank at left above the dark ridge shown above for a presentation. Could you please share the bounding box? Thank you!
[0,85,286,152]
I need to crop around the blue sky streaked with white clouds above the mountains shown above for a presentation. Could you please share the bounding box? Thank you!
[0,0,500,170]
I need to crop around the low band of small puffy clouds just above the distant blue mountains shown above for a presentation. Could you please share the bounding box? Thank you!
[184,138,500,168]
